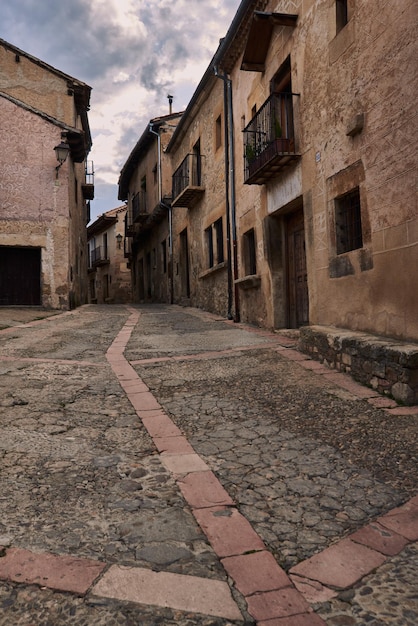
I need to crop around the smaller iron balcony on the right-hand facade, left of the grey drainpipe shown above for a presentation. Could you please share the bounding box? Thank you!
[172,153,204,207]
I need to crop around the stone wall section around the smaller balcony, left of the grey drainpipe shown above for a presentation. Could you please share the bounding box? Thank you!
[170,78,228,315]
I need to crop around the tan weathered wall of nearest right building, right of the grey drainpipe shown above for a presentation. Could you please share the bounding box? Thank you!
[227,0,418,340]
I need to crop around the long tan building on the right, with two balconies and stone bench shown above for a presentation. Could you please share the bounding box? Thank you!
[119,0,418,402]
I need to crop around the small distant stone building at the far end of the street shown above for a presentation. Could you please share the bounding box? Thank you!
[87,205,132,304]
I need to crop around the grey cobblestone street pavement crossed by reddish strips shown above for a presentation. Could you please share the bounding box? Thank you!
[0,305,418,626]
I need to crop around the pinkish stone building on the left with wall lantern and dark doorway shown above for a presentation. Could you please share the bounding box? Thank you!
[0,40,94,309]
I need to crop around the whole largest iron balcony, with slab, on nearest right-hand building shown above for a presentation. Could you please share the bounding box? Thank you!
[243,93,299,184]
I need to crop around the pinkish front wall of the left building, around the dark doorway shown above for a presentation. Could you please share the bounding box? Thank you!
[0,97,73,308]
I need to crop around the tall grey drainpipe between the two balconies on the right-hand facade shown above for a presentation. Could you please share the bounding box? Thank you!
[213,65,240,322]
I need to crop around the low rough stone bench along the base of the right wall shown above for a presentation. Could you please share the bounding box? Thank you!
[298,326,418,405]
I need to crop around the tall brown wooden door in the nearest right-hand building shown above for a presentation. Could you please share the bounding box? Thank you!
[286,209,309,328]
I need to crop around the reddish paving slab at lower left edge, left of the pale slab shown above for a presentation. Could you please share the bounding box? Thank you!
[0,548,106,594]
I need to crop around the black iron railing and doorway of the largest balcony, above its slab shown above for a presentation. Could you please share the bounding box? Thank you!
[243,93,295,179]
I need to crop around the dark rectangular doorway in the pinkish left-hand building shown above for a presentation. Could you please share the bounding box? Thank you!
[0,246,41,306]
